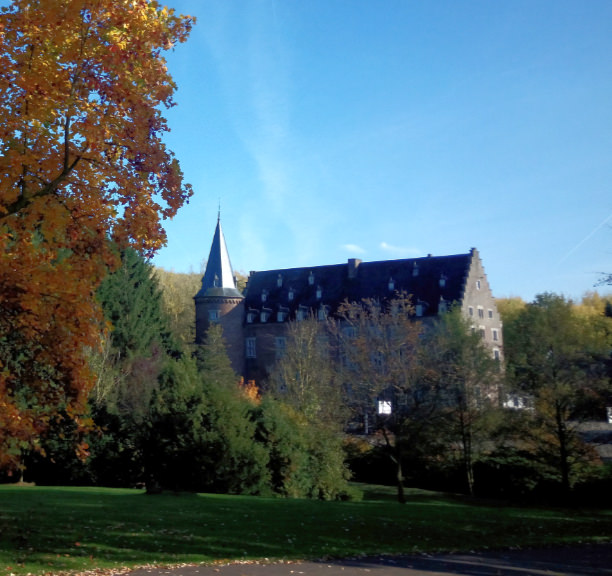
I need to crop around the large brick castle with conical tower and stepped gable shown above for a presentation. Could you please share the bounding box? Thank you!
[194,220,502,382]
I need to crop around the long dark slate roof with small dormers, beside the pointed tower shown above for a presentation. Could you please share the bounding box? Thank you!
[245,249,475,323]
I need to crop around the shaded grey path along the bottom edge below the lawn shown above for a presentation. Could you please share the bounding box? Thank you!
[123,542,612,576]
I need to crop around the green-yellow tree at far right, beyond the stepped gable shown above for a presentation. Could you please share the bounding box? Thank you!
[504,294,611,493]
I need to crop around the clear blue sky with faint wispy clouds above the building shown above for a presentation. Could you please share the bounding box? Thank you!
[154,0,612,300]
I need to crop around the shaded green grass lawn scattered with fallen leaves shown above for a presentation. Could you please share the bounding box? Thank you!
[0,485,612,576]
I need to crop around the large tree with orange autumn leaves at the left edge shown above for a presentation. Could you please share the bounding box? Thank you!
[0,0,191,466]
